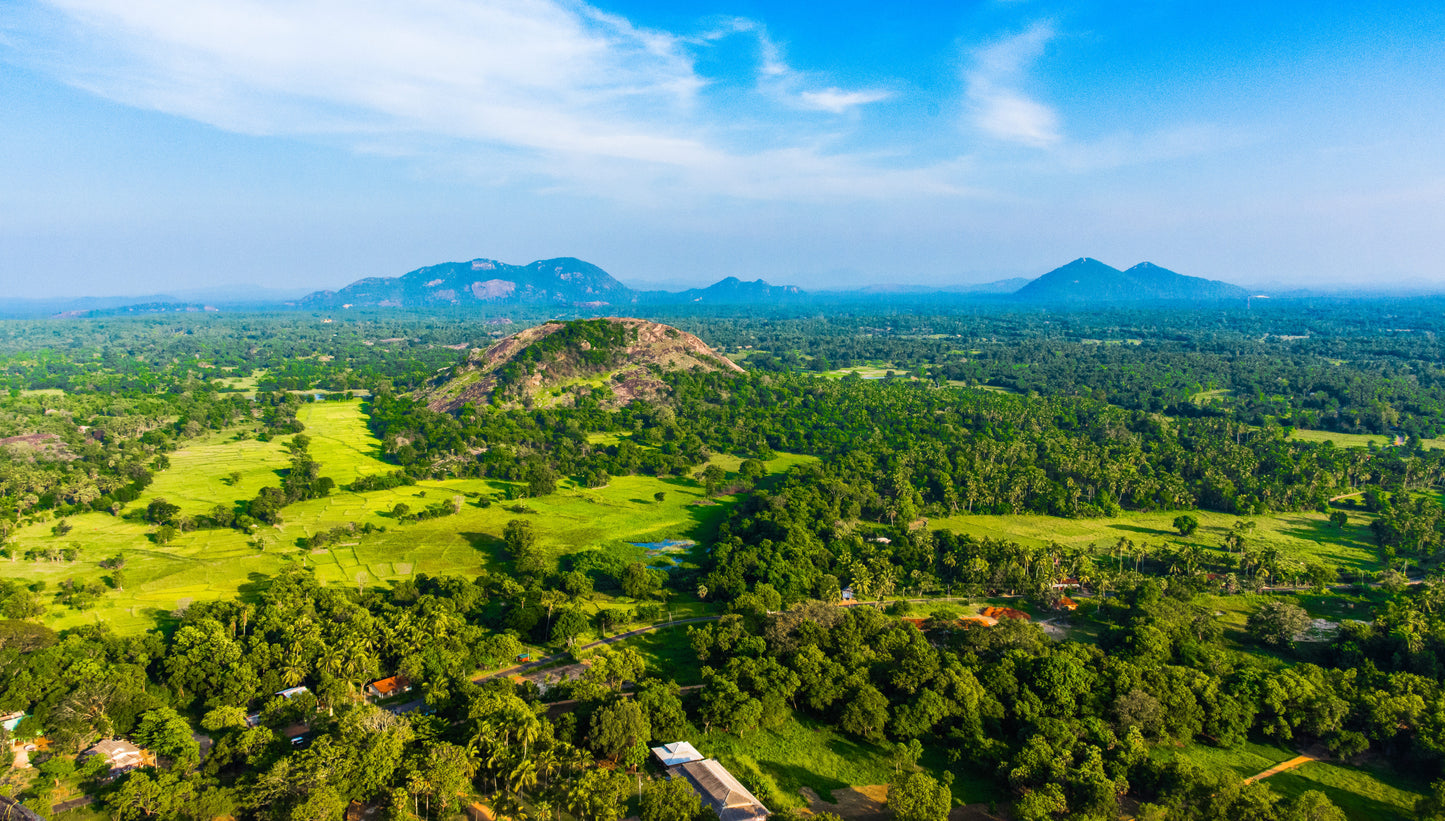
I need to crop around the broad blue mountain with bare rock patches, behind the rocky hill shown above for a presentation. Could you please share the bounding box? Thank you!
[301,257,633,308]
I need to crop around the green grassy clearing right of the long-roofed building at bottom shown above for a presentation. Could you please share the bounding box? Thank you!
[694,717,998,811]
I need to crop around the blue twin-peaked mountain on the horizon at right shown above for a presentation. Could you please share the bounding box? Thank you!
[1014,257,1250,304]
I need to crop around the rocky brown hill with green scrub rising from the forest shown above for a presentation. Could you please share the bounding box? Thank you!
[420,317,743,412]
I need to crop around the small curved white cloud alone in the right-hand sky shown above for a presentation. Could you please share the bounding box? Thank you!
[964,22,1064,147]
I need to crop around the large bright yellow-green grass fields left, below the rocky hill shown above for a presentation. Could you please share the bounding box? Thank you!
[3,402,802,632]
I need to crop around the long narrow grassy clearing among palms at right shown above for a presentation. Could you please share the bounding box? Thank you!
[929,510,1379,571]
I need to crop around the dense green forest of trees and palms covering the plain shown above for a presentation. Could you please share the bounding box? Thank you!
[0,307,1445,821]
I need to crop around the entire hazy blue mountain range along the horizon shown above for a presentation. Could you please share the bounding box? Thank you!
[0,257,1250,317]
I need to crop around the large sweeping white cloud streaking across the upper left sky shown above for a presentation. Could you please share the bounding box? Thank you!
[7,0,913,197]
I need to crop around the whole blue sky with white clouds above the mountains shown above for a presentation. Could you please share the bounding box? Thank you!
[0,0,1445,296]
